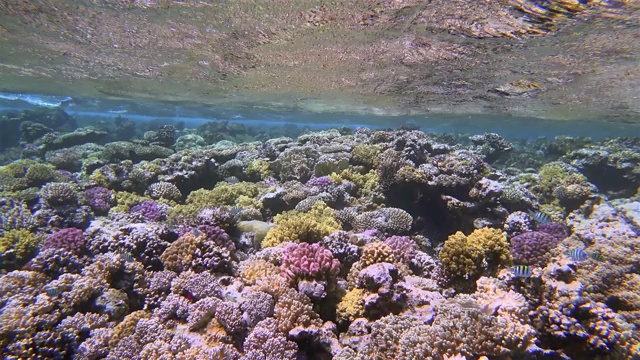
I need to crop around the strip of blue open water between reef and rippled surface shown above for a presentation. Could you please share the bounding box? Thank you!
[0,93,640,140]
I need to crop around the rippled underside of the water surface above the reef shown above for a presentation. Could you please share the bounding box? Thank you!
[0,0,640,122]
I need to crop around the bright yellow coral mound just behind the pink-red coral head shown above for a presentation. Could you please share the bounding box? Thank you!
[262,201,342,247]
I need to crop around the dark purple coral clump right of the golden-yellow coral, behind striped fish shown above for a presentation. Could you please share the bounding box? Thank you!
[511,231,562,266]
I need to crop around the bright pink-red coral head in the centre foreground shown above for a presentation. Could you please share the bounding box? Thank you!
[280,243,340,282]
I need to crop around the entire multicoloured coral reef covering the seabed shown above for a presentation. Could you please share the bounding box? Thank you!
[0,107,640,360]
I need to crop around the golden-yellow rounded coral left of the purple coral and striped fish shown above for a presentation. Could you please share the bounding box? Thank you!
[440,228,512,278]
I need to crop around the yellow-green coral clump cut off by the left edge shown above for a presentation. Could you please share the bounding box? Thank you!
[0,229,40,270]
